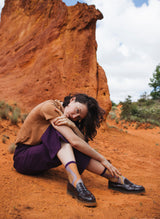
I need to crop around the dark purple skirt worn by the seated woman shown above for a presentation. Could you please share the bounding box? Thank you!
[13,125,91,175]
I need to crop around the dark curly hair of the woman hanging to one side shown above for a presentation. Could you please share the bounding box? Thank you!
[63,93,105,142]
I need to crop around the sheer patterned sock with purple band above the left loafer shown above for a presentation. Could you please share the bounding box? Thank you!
[65,161,83,187]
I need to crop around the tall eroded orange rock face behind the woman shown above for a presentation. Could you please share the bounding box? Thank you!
[0,0,111,112]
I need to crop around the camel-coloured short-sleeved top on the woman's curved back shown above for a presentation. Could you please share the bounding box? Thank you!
[15,100,64,145]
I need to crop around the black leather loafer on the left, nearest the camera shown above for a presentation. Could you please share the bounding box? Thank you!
[67,182,97,207]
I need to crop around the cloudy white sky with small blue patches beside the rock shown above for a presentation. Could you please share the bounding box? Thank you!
[0,0,160,103]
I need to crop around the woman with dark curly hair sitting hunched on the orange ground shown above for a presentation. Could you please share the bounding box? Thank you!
[14,94,144,206]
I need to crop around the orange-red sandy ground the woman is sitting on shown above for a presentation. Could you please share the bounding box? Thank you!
[0,121,160,219]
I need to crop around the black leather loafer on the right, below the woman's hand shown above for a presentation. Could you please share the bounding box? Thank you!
[108,178,145,193]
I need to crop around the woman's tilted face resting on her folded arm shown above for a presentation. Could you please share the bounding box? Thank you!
[64,97,88,122]
